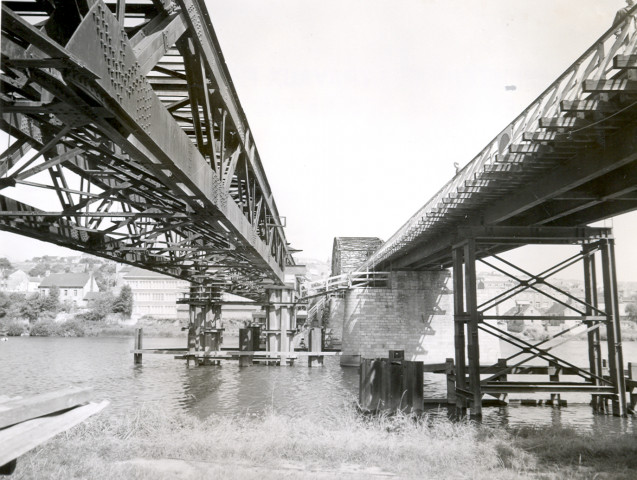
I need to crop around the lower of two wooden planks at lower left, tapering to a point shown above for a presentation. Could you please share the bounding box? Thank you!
[0,400,109,465]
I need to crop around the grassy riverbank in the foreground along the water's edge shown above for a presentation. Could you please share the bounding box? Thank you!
[12,409,637,480]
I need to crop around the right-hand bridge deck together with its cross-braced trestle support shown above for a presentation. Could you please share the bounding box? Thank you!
[360,7,637,417]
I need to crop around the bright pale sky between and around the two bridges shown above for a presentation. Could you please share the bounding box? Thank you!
[0,0,637,280]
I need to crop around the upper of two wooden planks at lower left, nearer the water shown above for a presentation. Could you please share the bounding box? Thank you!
[0,387,93,430]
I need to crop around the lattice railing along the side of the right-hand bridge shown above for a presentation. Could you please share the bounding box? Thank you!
[363,5,637,269]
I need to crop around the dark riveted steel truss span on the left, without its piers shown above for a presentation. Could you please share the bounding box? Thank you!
[0,0,294,295]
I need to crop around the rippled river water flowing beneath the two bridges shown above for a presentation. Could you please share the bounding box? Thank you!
[0,337,637,433]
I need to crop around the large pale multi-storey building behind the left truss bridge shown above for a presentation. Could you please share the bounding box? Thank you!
[119,266,190,320]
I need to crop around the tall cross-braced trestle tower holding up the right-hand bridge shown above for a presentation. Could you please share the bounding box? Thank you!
[447,227,632,418]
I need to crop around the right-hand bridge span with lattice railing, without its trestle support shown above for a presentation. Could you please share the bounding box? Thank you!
[365,11,637,268]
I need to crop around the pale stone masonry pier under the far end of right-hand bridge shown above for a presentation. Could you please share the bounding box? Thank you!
[341,270,500,366]
